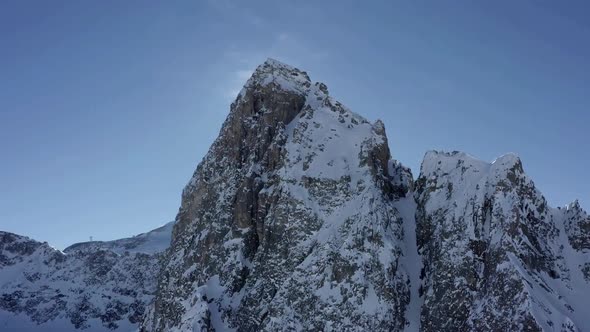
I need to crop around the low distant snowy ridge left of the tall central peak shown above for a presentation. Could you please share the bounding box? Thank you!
[0,223,173,331]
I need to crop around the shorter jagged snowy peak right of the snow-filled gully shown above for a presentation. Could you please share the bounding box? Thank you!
[414,152,590,331]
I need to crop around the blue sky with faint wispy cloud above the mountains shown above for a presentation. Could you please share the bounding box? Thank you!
[0,0,590,249]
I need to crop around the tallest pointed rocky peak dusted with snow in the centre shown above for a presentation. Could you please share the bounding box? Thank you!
[143,60,411,331]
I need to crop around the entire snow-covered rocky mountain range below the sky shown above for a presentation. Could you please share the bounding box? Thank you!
[0,59,590,331]
